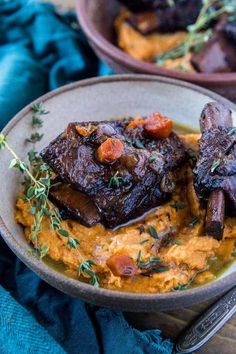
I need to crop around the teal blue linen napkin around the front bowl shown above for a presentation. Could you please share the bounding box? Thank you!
[0,0,173,354]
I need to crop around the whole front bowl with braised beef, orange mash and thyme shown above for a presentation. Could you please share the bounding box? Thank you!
[0,75,236,311]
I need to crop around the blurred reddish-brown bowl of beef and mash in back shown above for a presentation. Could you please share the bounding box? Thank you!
[77,0,236,101]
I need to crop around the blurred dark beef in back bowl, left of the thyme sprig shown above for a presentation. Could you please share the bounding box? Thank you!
[127,0,202,35]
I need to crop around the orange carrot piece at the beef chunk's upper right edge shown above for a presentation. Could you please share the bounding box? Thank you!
[144,112,173,138]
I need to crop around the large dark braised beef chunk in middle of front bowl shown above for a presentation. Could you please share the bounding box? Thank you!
[41,119,185,227]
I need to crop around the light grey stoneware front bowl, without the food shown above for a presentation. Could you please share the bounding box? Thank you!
[0,75,236,312]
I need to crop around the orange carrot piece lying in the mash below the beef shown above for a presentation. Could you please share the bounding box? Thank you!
[107,254,137,277]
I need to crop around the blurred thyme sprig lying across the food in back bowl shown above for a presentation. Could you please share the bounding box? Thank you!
[156,0,236,67]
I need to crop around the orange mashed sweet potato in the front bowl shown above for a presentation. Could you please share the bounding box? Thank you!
[16,134,236,293]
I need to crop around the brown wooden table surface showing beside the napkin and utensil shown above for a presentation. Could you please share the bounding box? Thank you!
[44,0,236,354]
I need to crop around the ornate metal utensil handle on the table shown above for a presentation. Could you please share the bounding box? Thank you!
[175,287,236,353]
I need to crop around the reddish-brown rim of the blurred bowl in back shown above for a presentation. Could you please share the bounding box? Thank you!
[76,0,236,86]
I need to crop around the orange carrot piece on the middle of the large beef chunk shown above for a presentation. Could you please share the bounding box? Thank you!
[97,138,124,162]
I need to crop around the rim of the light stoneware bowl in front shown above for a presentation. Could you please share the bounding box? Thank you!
[0,74,236,312]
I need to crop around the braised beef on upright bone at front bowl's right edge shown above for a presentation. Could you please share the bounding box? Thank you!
[194,103,236,215]
